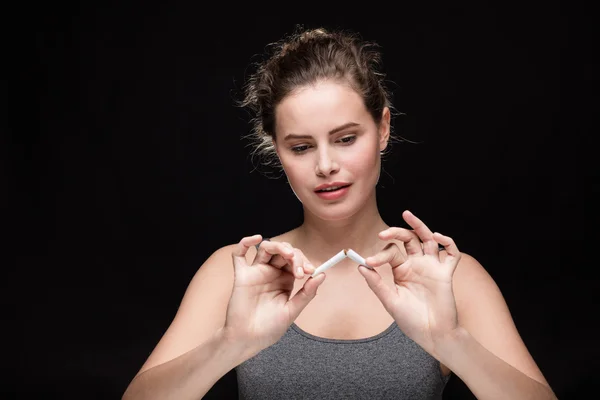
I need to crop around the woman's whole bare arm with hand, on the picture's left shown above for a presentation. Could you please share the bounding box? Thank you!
[123,235,325,400]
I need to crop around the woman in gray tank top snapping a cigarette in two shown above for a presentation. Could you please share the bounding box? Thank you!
[124,29,555,399]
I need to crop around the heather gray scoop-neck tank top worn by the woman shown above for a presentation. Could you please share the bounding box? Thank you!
[236,322,450,400]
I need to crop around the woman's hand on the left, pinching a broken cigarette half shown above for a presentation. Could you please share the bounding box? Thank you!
[223,235,325,356]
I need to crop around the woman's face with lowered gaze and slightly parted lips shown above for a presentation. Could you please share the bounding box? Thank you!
[275,81,390,220]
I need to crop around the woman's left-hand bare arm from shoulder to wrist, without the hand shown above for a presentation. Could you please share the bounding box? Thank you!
[123,245,244,400]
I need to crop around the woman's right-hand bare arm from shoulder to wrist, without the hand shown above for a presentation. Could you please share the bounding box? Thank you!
[435,253,556,399]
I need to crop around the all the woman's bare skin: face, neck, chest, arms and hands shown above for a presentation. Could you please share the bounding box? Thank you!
[124,77,556,399]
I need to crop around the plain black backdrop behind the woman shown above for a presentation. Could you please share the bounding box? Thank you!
[7,2,599,399]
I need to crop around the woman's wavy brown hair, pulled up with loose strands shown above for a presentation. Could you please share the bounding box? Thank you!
[240,28,398,170]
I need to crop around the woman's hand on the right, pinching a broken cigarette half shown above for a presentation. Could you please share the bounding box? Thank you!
[359,211,461,355]
